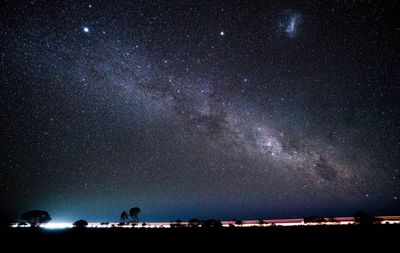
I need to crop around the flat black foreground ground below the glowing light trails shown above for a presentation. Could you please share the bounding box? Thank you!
[1,225,400,252]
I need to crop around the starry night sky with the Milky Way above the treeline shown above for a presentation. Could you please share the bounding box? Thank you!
[0,0,400,221]
